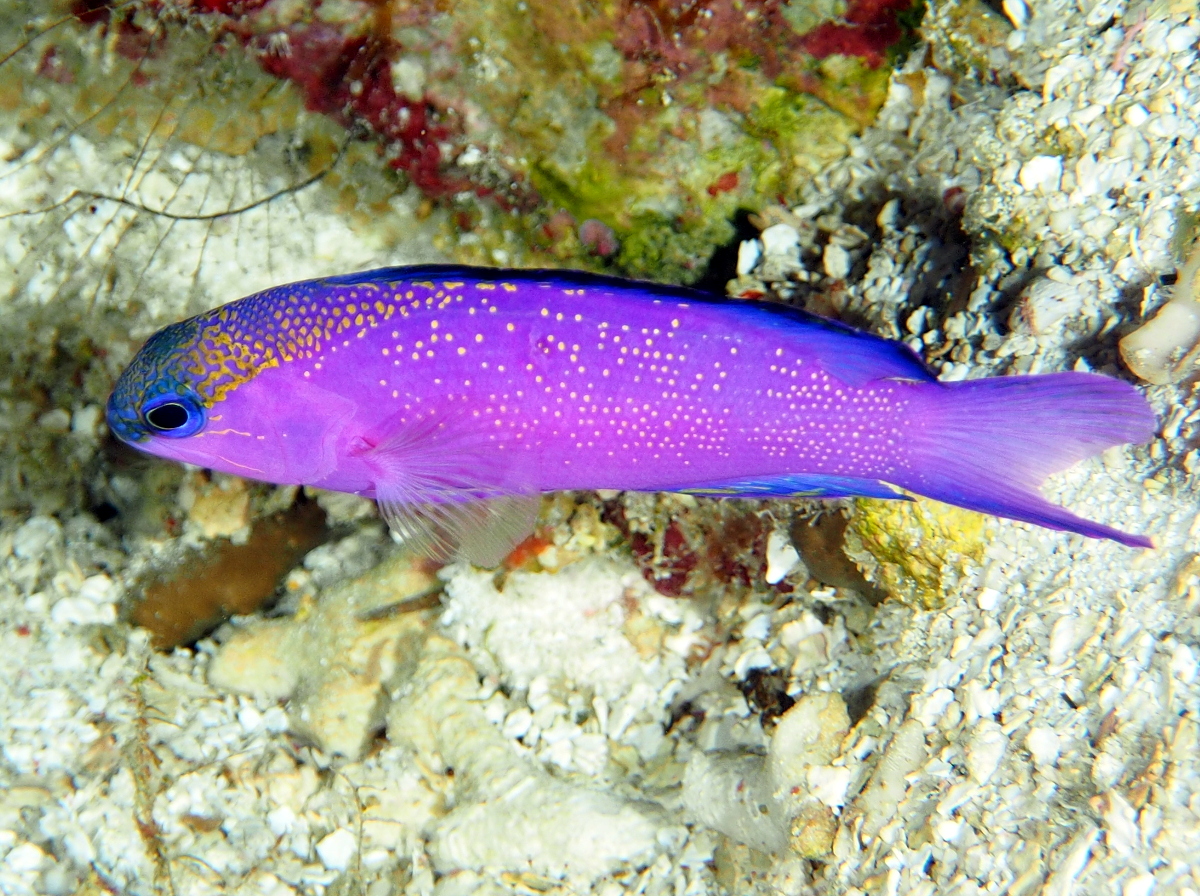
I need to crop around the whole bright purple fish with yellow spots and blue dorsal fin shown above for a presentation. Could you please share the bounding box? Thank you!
[108,266,1156,559]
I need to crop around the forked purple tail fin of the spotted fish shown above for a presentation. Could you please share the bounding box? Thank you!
[895,373,1156,547]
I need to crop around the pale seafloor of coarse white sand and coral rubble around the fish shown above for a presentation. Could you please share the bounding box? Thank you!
[0,0,1200,896]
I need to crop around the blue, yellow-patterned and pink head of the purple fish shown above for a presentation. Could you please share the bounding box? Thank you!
[107,308,354,483]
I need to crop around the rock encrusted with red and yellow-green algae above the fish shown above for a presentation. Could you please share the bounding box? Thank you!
[7,0,912,282]
